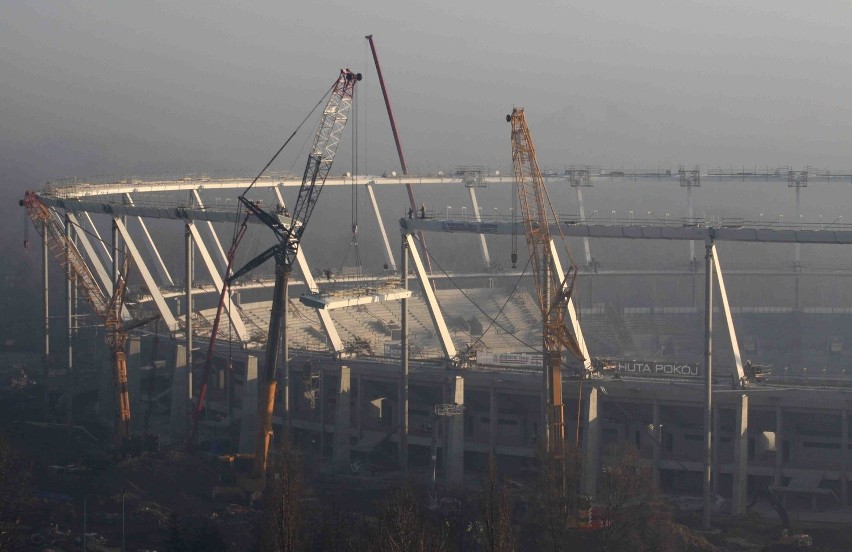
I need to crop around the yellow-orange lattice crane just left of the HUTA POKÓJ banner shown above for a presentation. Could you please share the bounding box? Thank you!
[506,108,585,455]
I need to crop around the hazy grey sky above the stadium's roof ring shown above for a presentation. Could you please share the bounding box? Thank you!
[0,0,852,193]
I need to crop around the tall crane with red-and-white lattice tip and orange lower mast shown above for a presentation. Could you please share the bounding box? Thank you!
[189,69,361,488]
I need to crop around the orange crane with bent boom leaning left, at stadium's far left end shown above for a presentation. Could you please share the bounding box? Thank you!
[20,192,159,446]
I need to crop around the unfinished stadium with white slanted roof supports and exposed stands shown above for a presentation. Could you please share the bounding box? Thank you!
[21,167,852,528]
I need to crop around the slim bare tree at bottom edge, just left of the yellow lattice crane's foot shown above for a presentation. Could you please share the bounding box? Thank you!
[479,454,515,552]
